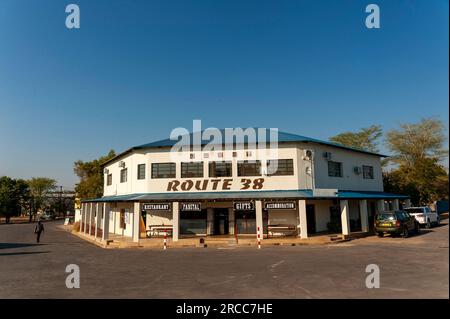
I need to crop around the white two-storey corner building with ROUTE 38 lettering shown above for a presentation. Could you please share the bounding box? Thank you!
[78,130,408,242]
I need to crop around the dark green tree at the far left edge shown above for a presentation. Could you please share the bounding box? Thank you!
[0,176,29,223]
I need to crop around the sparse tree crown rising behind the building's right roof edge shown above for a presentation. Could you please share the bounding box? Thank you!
[330,125,383,153]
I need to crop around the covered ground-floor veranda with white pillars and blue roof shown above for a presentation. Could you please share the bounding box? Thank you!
[80,190,410,243]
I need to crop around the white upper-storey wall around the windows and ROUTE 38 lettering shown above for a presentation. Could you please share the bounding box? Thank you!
[104,143,383,196]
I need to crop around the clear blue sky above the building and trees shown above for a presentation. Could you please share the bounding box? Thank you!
[0,0,449,188]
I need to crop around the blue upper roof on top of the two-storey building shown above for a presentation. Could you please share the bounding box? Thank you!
[102,128,388,165]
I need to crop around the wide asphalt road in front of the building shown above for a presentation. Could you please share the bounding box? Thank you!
[0,222,449,298]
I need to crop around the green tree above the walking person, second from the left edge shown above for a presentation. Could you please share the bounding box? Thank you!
[25,177,56,222]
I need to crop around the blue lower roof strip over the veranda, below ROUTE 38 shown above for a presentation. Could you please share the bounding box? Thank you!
[82,189,409,203]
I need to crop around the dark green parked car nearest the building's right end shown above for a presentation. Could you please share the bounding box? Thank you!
[374,210,420,238]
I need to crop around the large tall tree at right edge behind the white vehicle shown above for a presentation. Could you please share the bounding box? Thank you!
[384,119,448,205]
